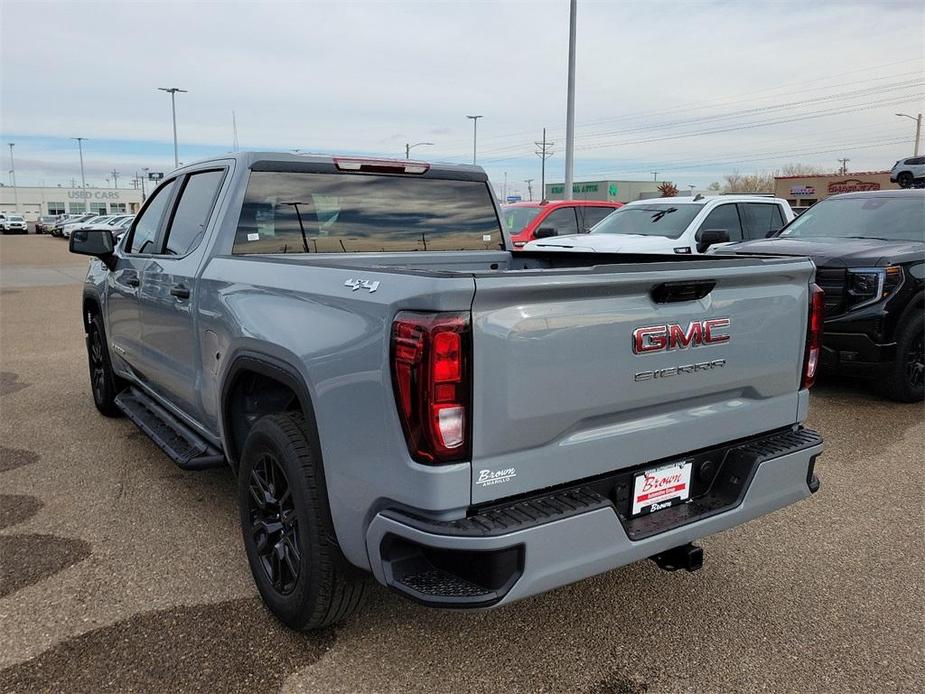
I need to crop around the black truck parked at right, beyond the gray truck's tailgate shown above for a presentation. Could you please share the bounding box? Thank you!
[719,190,925,402]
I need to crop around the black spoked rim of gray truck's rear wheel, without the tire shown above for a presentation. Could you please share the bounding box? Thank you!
[249,452,302,595]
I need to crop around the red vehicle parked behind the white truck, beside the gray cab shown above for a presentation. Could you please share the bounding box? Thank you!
[501,200,623,248]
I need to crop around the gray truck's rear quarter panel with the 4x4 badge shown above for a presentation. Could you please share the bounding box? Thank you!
[199,256,473,567]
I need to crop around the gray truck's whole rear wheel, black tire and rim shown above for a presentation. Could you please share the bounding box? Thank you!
[238,413,369,631]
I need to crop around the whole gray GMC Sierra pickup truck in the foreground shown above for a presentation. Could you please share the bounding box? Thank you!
[70,153,822,629]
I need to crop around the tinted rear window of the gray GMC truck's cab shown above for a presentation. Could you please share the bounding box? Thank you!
[232,171,502,255]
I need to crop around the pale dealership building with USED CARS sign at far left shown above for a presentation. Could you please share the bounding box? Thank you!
[0,186,142,222]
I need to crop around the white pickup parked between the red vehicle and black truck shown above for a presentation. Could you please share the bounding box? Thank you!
[524,195,794,254]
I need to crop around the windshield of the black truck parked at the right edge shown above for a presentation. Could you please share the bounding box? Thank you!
[778,195,925,241]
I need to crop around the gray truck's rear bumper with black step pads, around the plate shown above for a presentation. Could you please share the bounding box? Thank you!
[366,429,823,608]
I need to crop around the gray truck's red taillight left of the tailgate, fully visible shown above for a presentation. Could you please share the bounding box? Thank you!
[392,311,470,463]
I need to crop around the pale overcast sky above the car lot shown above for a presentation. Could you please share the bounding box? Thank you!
[0,0,925,193]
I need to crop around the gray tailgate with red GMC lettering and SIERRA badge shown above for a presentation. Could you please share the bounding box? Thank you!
[472,259,813,504]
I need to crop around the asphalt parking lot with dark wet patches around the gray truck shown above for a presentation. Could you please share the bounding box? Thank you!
[0,236,925,694]
